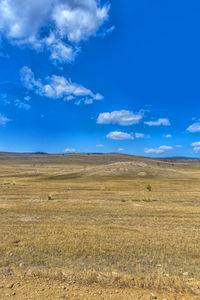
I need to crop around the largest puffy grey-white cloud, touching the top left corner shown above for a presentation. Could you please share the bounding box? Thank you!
[0,0,112,62]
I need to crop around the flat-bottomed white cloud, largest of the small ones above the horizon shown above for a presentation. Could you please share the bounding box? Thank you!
[97,110,143,126]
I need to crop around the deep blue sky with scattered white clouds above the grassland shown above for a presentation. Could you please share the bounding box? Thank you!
[0,0,200,157]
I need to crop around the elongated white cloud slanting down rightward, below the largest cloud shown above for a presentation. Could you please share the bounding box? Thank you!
[20,67,103,104]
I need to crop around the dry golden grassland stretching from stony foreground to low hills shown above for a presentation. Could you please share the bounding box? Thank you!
[0,153,200,300]
